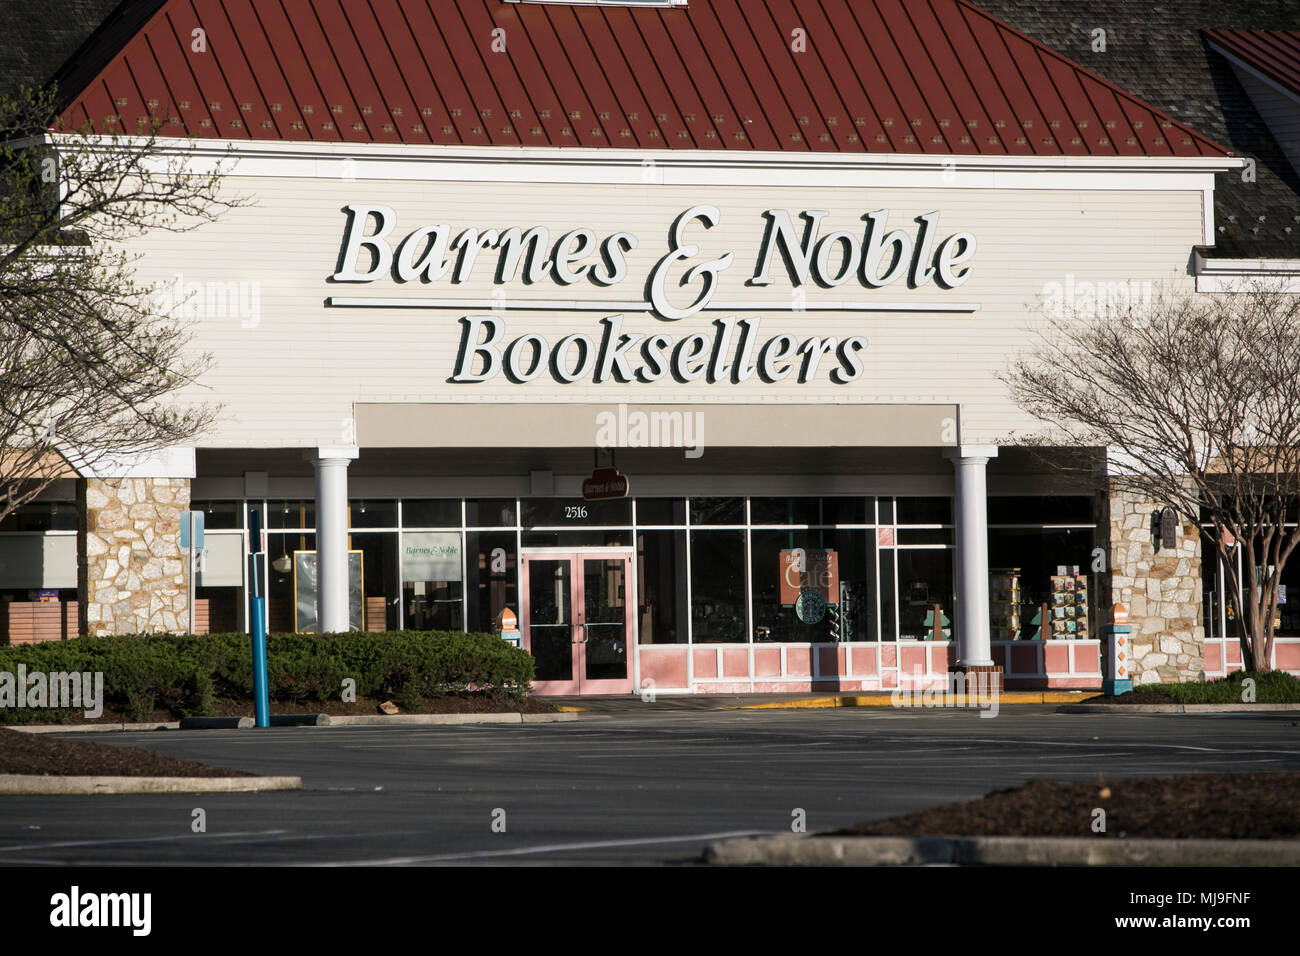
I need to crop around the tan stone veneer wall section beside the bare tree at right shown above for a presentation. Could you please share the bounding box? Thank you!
[1100,485,1205,685]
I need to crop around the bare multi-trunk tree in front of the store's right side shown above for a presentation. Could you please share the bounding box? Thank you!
[1004,285,1300,671]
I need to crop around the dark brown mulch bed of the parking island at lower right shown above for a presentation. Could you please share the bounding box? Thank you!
[837,773,1300,840]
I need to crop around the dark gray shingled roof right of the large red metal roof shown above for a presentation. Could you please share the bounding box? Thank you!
[971,0,1300,259]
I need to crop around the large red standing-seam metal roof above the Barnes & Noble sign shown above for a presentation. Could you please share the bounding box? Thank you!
[50,0,1227,156]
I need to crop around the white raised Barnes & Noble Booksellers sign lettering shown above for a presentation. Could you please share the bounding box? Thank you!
[330,204,975,384]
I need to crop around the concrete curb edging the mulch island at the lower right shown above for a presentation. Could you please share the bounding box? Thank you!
[705,834,1300,866]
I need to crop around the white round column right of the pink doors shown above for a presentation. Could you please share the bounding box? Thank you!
[945,445,997,666]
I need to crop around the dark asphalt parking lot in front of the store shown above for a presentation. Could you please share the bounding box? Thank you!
[0,706,1300,866]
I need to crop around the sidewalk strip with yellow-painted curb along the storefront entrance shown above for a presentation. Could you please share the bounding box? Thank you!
[543,691,1100,713]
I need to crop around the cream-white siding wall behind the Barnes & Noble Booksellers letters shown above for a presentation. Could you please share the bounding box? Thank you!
[124,173,1204,447]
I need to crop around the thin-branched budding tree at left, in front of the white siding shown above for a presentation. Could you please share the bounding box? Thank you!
[0,90,242,520]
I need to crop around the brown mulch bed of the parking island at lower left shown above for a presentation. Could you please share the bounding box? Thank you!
[0,727,256,777]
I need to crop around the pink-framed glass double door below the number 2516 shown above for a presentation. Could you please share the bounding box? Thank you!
[520,549,634,695]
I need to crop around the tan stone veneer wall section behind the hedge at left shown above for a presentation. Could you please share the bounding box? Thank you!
[77,479,190,635]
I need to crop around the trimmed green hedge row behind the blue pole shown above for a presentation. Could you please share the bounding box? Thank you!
[0,631,533,723]
